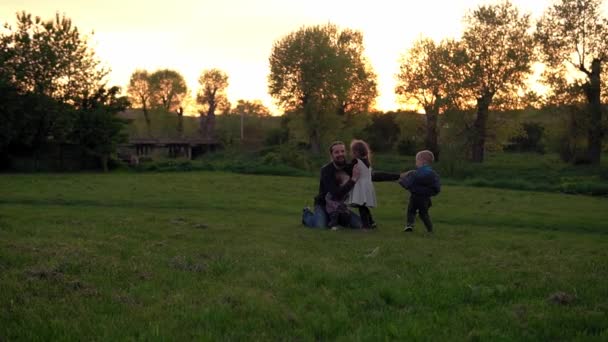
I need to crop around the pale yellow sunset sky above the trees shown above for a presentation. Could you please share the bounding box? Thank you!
[0,0,608,114]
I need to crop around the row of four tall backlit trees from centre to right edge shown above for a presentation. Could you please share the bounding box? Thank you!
[268,0,608,164]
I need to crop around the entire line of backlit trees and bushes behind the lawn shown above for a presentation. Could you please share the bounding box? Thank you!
[0,0,608,171]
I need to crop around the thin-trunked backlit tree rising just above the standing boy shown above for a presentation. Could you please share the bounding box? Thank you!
[395,38,462,159]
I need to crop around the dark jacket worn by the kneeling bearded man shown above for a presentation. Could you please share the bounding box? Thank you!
[315,162,399,206]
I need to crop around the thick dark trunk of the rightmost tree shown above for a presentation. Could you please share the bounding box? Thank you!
[583,59,602,165]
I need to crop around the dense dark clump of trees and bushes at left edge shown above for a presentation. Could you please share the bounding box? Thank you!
[0,12,128,169]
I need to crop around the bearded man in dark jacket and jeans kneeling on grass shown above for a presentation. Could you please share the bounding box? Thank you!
[302,141,399,229]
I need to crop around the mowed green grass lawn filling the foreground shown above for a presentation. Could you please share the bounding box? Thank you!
[0,172,608,341]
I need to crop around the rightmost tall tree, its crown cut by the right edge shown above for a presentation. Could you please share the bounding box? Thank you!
[536,0,608,164]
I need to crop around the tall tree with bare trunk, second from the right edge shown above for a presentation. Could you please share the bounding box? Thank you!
[462,1,534,162]
